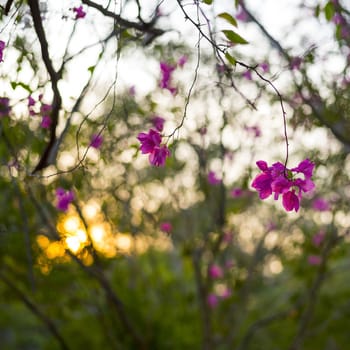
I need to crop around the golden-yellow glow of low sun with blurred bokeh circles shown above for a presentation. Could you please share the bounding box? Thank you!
[36,201,172,274]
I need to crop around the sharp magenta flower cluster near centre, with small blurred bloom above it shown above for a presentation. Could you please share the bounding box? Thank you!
[137,116,170,166]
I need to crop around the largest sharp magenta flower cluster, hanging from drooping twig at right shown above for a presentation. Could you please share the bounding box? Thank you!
[252,159,315,212]
